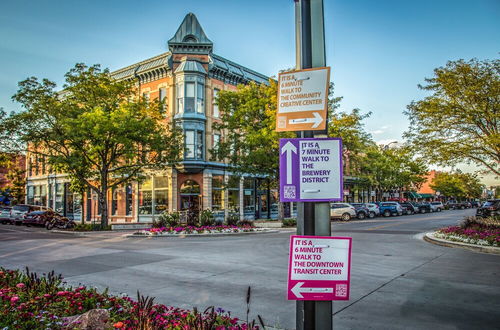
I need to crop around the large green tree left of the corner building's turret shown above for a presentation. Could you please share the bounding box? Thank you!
[4,64,182,226]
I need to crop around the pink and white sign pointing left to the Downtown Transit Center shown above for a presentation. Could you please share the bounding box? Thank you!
[288,235,352,300]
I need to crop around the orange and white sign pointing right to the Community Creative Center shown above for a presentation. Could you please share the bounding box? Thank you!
[276,67,330,132]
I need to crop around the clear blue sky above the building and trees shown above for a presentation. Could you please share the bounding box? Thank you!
[0,0,500,180]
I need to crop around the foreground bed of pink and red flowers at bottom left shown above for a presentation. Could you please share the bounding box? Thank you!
[0,268,258,329]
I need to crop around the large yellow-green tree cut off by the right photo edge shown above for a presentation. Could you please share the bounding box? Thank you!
[405,59,500,175]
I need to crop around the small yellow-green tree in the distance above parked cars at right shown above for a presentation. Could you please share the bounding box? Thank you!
[430,171,484,199]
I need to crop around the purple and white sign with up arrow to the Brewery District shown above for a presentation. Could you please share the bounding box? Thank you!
[280,138,343,202]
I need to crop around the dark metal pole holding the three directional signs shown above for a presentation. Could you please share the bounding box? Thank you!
[295,0,333,330]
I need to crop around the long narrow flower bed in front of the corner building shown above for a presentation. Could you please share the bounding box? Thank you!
[134,225,265,236]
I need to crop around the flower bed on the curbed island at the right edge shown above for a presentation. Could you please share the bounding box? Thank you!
[435,217,500,246]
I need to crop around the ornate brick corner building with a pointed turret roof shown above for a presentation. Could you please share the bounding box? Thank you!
[26,13,290,223]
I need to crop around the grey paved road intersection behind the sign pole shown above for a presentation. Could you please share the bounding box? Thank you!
[0,210,500,329]
